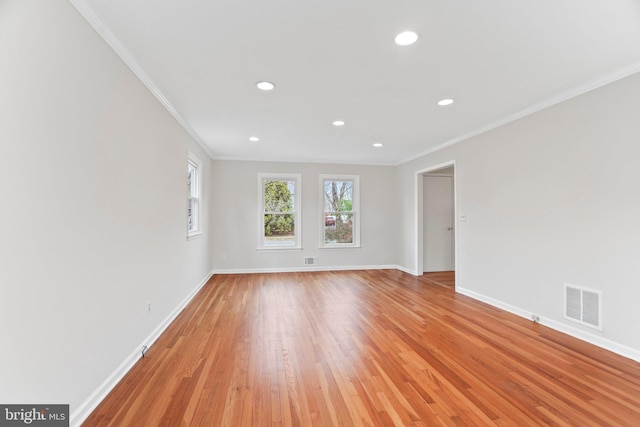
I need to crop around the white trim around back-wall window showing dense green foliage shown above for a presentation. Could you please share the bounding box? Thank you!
[257,173,302,251]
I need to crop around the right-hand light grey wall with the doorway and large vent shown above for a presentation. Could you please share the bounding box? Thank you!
[397,74,640,358]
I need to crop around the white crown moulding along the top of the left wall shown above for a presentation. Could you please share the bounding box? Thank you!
[69,0,213,158]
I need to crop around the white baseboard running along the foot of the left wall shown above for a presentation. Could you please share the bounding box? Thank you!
[69,271,214,427]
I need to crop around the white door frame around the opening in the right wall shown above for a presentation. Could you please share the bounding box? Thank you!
[414,159,460,287]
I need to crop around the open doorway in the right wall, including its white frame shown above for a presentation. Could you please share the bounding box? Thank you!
[417,162,457,288]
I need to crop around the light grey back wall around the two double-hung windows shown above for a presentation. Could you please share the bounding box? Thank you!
[212,160,399,272]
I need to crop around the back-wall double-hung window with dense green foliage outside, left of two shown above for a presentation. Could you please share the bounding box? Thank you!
[258,173,301,249]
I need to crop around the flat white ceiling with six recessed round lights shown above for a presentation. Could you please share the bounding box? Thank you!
[70,0,640,164]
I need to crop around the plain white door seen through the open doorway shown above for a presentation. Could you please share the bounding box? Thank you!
[423,175,455,272]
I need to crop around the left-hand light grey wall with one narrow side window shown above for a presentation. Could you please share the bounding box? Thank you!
[0,0,212,422]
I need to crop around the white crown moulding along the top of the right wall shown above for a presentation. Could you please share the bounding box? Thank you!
[393,62,640,166]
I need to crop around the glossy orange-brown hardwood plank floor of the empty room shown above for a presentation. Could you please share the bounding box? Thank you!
[83,270,640,426]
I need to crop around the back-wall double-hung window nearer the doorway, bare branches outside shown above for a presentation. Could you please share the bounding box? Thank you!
[320,175,360,248]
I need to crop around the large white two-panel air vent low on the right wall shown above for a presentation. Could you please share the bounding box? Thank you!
[564,283,602,330]
